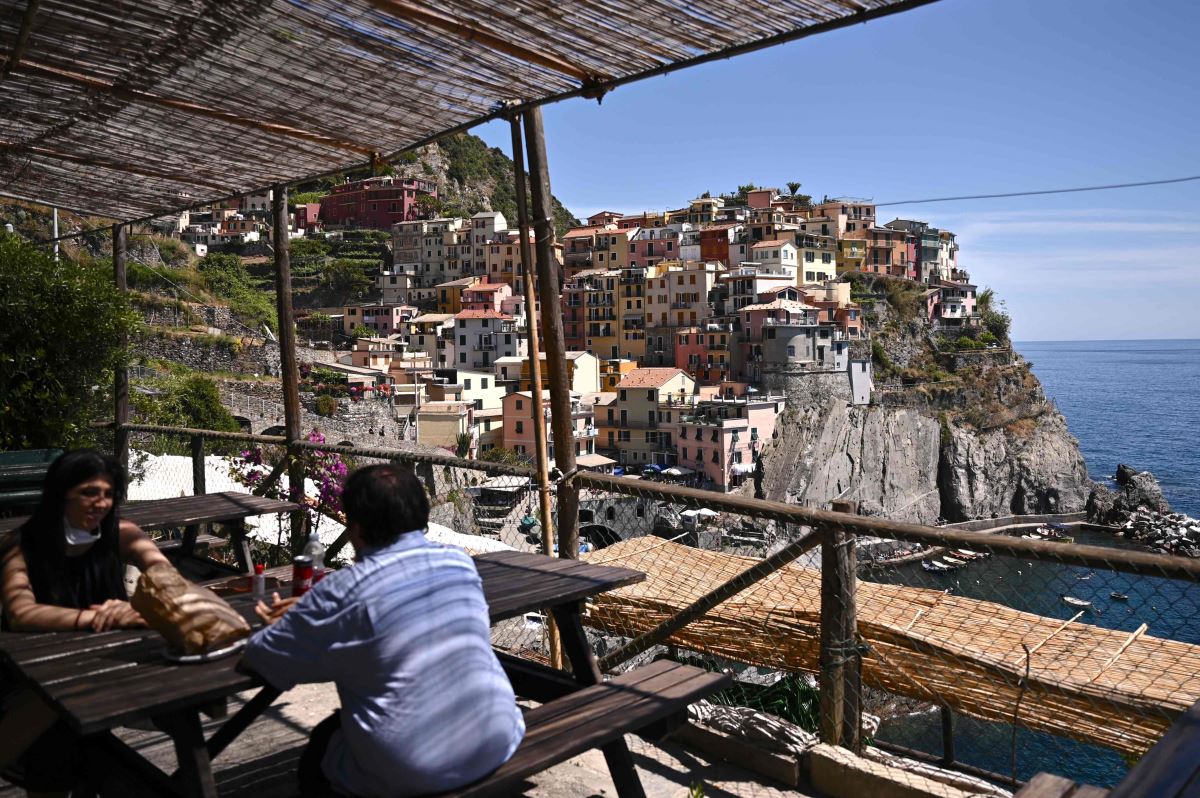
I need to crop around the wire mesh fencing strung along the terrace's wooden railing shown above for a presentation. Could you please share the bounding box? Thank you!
[110,425,1200,786]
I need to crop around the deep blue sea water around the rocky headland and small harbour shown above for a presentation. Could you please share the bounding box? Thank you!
[868,341,1200,786]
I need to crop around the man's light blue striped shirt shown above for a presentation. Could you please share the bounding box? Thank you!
[242,532,524,796]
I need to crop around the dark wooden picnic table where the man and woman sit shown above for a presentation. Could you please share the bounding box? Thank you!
[0,552,646,797]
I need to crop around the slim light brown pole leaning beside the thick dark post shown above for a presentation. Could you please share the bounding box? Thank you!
[509,116,563,668]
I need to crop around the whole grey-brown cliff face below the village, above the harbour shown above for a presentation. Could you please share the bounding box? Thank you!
[763,360,1093,523]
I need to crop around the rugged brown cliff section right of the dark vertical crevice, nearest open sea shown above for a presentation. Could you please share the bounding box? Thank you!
[938,412,1092,521]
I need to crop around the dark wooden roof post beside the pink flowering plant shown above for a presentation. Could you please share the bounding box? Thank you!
[271,184,306,553]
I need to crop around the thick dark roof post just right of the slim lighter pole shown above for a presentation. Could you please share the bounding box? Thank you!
[523,107,580,559]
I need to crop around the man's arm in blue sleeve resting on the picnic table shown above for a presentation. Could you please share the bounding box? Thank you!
[241,578,374,690]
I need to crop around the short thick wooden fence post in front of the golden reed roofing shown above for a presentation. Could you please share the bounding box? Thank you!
[820,502,863,752]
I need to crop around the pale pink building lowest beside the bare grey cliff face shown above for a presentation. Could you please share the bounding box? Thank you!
[672,395,785,491]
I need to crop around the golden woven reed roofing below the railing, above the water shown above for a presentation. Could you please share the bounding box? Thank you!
[583,538,1200,755]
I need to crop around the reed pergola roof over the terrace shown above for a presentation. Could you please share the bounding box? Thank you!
[0,0,932,221]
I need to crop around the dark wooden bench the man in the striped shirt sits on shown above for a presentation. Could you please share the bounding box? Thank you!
[440,658,732,798]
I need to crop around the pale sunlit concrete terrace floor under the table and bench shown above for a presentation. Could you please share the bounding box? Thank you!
[0,684,820,798]
